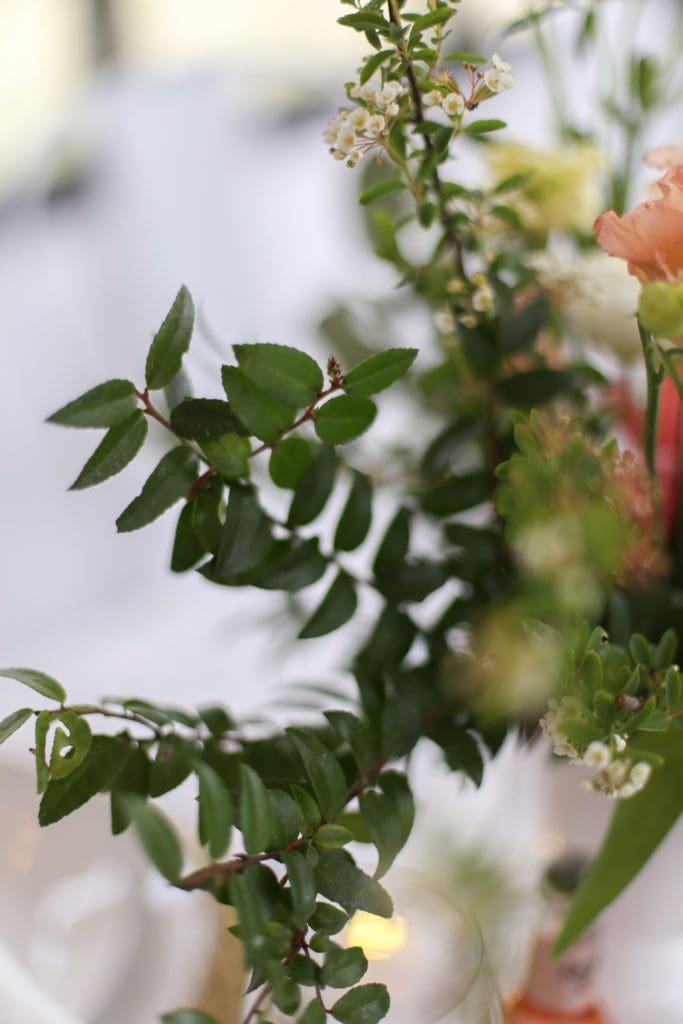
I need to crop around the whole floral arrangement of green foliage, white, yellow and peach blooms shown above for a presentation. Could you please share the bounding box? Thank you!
[0,0,683,1024]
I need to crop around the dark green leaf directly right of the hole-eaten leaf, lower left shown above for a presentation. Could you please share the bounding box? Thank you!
[38,737,130,825]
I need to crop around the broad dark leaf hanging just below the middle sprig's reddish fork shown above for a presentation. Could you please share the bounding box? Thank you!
[213,485,274,583]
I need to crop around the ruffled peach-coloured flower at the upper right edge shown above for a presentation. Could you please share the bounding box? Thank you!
[595,167,683,284]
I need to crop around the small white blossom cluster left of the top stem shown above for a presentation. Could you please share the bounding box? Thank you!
[323,75,405,167]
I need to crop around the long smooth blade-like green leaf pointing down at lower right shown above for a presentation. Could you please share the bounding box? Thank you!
[555,729,683,953]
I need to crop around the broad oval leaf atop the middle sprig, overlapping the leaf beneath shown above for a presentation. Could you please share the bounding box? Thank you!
[232,344,324,409]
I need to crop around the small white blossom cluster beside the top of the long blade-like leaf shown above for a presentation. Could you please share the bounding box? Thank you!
[541,697,652,800]
